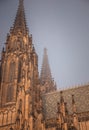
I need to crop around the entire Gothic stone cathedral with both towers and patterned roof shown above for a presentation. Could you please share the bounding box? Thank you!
[0,0,89,130]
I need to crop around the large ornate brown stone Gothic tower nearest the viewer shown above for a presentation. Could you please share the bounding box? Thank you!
[0,0,42,130]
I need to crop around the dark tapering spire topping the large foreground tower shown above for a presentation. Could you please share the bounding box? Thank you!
[12,0,28,34]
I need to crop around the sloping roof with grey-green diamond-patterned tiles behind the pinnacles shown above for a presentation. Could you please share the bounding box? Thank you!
[43,85,89,119]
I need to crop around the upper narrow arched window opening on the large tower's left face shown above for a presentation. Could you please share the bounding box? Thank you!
[9,62,15,82]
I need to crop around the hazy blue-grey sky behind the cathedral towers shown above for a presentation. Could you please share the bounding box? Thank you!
[0,0,89,89]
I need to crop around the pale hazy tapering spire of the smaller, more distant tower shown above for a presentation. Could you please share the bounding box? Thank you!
[40,48,52,83]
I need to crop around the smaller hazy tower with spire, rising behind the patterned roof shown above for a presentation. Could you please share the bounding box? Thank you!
[40,48,56,93]
